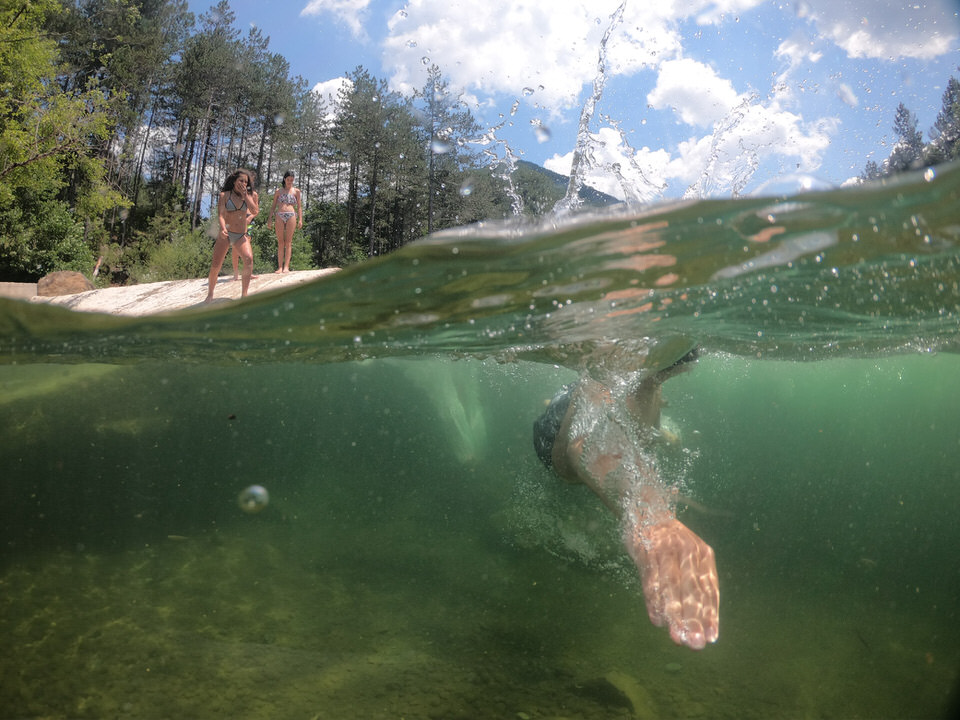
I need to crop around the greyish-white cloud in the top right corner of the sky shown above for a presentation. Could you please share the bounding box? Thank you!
[803,0,958,60]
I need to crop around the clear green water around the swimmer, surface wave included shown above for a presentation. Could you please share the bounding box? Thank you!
[0,170,960,719]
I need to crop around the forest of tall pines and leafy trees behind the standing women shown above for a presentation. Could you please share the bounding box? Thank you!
[0,0,562,283]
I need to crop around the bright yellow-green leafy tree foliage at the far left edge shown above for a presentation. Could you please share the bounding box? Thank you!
[0,0,123,279]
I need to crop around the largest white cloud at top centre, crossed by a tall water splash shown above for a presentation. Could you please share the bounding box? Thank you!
[383,0,704,112]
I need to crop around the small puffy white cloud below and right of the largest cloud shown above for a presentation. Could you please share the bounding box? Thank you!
[647,58,743,127]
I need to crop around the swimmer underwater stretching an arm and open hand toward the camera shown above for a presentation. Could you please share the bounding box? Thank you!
[534,350,720,650]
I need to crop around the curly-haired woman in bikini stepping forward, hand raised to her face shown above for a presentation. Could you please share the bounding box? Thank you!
[205,170,260,302]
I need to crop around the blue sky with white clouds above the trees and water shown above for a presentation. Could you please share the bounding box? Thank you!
[190,0,960,201]
